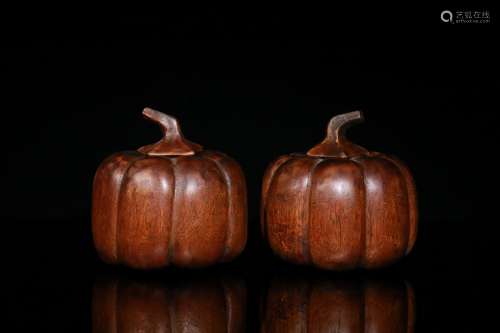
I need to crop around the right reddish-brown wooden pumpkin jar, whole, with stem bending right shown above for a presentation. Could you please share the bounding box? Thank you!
[261,111,417,270]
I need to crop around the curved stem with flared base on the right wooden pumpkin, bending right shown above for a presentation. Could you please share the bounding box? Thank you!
[307,111,367,157]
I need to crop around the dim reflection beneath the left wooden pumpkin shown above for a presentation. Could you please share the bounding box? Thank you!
[92,278,246,333]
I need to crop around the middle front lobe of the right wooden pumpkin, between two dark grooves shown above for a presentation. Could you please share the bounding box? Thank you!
[309,159,365,269]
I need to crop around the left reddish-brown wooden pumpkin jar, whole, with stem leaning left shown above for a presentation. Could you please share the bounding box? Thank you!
[92,108,247,269]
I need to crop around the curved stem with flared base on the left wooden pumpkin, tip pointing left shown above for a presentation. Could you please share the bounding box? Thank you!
[138,108,203,156]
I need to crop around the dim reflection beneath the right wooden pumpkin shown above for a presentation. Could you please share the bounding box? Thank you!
[261,278,415,333]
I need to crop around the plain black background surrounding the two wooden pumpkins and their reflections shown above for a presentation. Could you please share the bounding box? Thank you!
[0,7,500,332]
